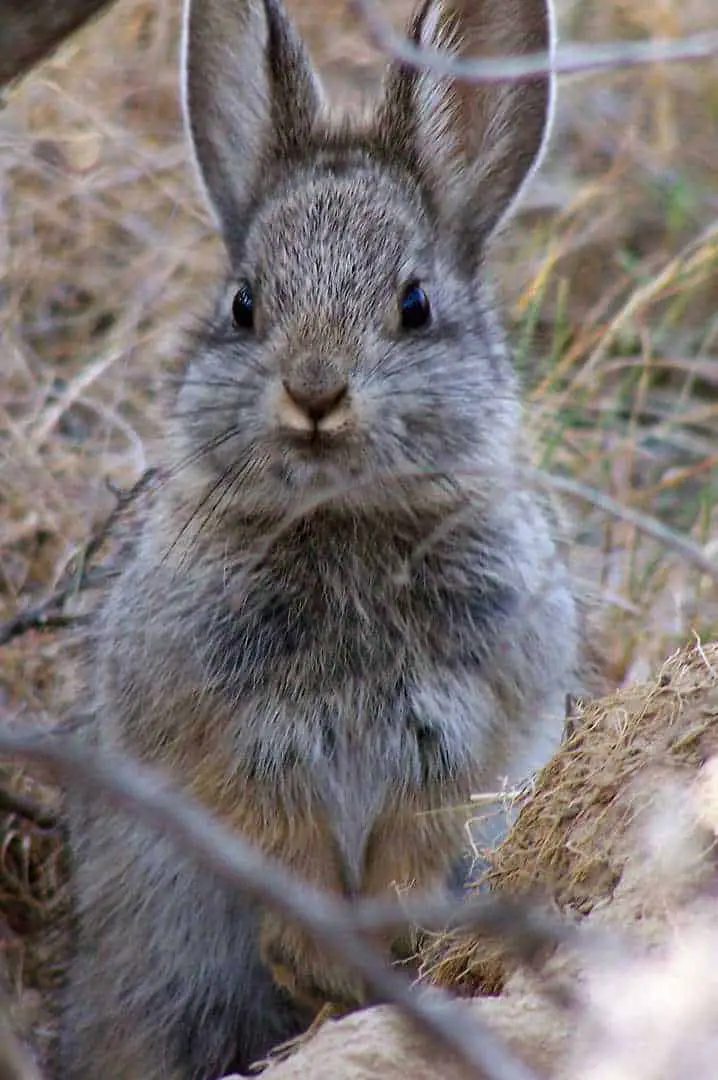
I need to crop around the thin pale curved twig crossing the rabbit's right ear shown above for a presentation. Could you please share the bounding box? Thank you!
[347,0,718,82]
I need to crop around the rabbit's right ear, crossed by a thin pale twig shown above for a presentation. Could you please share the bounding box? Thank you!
[381,0,554,257]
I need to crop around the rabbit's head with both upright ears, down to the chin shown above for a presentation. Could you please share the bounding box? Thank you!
[174,0,553,514]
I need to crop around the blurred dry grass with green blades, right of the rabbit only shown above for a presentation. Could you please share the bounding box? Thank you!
[504,2,718,679]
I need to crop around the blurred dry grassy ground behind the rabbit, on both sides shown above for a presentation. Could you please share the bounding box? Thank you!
[0,0,718,1071]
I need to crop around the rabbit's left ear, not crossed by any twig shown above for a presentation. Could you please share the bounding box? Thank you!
[182,0,321,237]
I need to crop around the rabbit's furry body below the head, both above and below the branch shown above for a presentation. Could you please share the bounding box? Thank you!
[63,499,578,1080]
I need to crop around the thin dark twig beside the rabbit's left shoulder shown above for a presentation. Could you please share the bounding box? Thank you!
[0,469,155,646]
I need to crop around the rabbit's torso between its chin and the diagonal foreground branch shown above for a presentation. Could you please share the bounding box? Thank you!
[100,490,577,895]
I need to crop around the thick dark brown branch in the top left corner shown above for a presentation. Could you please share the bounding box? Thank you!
[0,0,114,91]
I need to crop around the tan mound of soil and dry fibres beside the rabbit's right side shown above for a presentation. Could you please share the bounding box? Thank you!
[424,644,718,996]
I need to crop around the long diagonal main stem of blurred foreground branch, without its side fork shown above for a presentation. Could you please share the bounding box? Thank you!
[0,729,544,1080]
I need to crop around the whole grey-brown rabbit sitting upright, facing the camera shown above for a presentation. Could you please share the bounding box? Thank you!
[59,0,600,1080]
